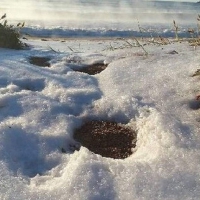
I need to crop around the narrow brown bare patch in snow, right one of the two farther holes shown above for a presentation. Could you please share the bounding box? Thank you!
[74,63,107,75]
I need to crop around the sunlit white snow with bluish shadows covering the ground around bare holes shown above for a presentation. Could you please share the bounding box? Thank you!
[0,39,200,200]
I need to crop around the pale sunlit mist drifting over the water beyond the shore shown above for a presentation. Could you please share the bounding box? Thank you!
[0,0,199,29]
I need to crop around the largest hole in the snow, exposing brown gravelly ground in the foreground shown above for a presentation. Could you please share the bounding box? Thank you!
[74,120,137,159]
